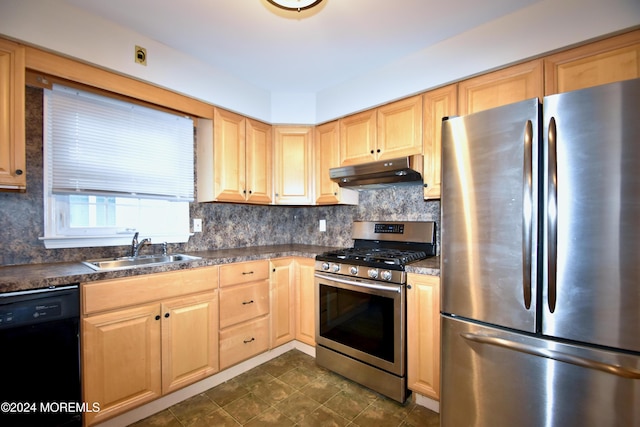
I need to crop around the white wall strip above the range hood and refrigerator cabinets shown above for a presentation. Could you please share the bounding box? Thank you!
[315,0,640,123]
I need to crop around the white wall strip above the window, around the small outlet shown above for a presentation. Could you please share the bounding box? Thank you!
[0,0,271,121]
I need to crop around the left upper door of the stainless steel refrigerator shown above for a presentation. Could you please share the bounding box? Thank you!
[441,99,539,332]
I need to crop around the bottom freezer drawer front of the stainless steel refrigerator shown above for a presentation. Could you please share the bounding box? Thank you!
[440,317,640,427]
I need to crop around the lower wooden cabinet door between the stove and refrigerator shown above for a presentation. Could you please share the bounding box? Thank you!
[407,274,440,400]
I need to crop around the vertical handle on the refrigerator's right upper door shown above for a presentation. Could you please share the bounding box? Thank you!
[547,117,558,313]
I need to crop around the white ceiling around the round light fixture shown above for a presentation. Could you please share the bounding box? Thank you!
[64,0,539,93]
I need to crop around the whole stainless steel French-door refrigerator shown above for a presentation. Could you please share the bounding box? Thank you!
[440,79,640,427]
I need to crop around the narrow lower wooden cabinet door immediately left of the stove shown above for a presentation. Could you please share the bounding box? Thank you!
[296,258,316,346]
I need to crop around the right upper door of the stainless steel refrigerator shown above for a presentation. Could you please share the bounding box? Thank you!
[541,79,640,352]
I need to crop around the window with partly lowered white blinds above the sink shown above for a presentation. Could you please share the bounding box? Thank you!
[43,85,194,248]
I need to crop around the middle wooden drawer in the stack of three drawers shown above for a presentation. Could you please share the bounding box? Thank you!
[220,280,269,329]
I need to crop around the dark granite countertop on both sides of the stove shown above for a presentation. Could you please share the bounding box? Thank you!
[0,245,440,293]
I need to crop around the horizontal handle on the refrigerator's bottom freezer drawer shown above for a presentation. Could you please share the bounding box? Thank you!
[460,332,640,380]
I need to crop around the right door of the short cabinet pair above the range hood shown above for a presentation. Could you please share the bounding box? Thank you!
[376,96,422,160]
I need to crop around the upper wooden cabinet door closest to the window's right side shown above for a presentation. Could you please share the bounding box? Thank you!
[213,108,246,202]
